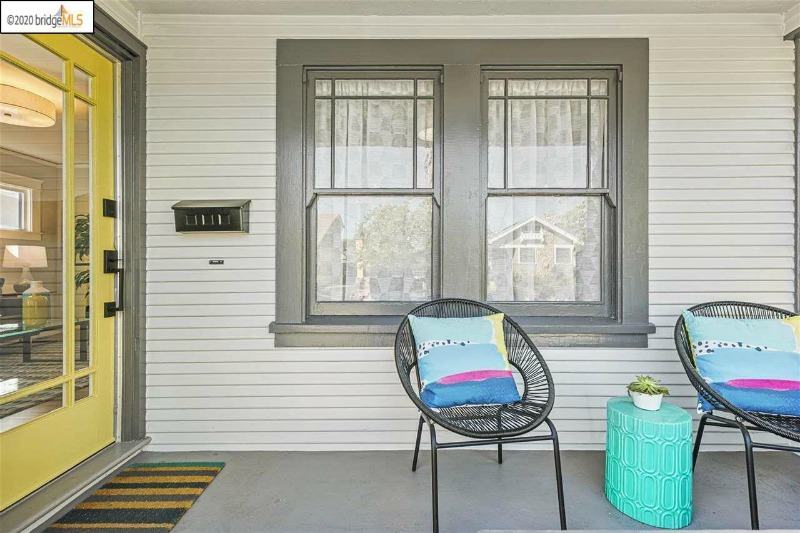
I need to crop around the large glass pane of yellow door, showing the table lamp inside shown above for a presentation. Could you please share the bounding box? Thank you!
[0,61,64,392]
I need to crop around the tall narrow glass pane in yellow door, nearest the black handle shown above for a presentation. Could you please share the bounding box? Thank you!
[73,98,93,370]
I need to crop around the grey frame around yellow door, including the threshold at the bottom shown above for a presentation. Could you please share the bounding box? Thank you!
[0,5,149,532]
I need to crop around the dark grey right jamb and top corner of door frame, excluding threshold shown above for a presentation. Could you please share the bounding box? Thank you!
[86,5,147,442]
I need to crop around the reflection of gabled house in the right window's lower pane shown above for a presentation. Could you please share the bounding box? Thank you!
[488,216,583,301]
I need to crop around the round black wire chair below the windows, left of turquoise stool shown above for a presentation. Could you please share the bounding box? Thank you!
[394,298,567,533]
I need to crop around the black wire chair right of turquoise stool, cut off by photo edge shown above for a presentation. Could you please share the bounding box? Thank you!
[675,302,800,529]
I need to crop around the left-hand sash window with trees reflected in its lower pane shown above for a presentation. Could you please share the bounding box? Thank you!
[306,69,441,315]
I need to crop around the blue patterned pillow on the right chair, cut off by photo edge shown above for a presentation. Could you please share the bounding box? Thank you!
[683,311,800,416]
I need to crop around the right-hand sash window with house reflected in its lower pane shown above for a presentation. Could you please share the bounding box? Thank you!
[482,67,618,317]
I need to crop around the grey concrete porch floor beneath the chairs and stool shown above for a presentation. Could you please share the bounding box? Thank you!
[130,449,800,533]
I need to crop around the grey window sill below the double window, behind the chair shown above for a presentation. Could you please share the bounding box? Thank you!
[269,316,656,348]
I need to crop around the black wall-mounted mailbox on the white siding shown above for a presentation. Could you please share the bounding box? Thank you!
[172,200,250,233]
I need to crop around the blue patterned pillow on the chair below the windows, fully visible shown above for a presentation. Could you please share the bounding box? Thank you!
[409,313,520,408]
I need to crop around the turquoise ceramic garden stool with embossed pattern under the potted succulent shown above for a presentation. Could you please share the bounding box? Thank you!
[606,397,692,529]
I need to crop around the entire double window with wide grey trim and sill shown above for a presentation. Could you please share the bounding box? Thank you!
[270,39,654,346]
